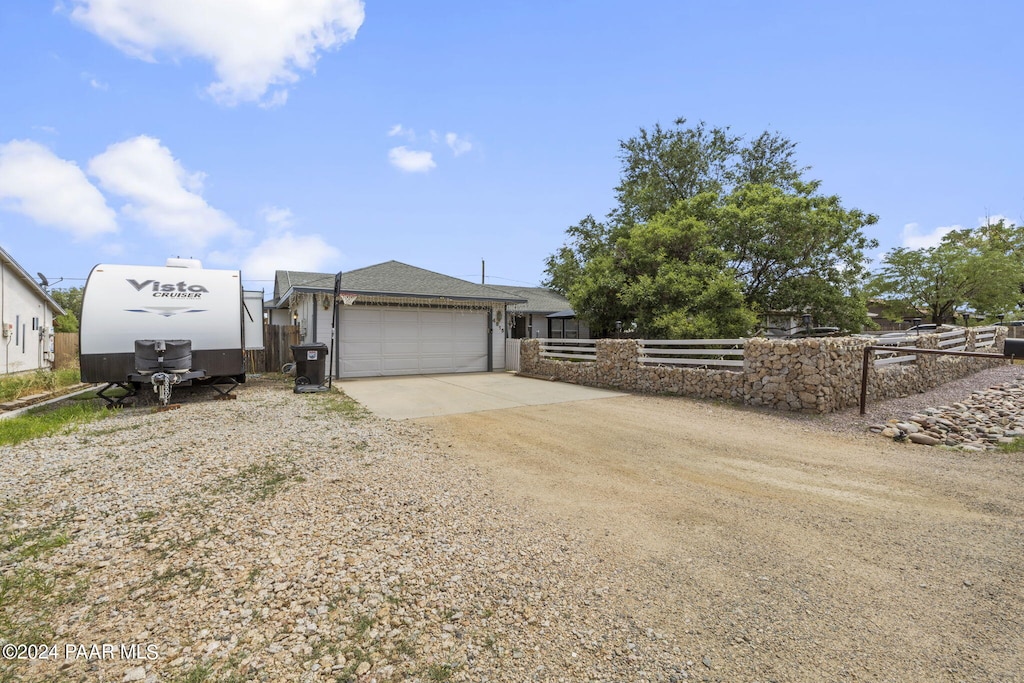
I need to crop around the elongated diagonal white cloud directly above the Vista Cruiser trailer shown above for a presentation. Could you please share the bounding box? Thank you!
[89,135,240,248]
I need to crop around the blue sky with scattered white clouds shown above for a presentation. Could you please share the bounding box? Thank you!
[0,0,1024,291]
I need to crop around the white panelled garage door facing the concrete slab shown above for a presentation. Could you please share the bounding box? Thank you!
[332,306,487,378]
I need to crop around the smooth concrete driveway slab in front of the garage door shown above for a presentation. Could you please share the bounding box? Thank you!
[335,373,623,420]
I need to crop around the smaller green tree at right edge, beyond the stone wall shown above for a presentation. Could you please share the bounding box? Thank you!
[869,220,1024,324]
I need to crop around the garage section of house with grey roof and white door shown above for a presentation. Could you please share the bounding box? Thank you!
[268,261,525,379]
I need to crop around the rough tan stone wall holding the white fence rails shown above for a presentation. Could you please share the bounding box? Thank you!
[520,328,1006,413]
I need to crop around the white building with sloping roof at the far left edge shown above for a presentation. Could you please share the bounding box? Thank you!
[0,247,65,375]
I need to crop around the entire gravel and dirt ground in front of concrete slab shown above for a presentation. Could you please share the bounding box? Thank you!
[0,380,1024,682]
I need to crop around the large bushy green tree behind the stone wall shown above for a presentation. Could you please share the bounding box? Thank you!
[547,119,876,336]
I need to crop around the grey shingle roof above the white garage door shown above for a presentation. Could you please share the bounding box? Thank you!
[273,261,524,303]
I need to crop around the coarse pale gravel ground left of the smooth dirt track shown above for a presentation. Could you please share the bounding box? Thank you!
[0,381,685,681]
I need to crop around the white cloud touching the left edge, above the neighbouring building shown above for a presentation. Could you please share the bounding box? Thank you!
[0,140,118,240]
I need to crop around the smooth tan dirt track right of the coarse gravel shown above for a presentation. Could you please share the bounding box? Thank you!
[419,396,1024,681]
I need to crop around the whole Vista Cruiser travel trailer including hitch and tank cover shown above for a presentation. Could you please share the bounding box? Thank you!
[79,258,263,405]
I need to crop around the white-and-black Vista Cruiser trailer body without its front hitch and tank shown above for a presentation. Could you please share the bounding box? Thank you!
[79,259,263,383]
